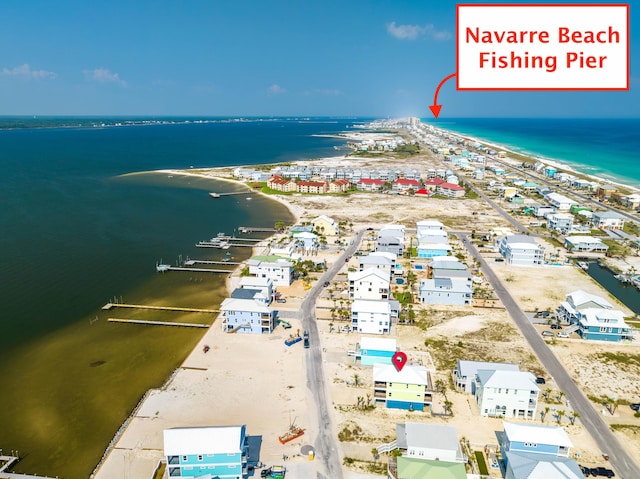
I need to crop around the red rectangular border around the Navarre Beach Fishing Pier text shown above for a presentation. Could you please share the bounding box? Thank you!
[456,3,631,91]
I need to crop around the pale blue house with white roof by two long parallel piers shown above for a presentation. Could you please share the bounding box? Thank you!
[220,298,278,334]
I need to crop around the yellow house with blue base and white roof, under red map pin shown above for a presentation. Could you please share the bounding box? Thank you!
[373,363,433,411]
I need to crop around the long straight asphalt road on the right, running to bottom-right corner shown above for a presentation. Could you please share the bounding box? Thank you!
[457,233,640,479]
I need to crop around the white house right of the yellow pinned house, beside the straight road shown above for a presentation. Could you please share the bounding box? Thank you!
[475,369,540,419]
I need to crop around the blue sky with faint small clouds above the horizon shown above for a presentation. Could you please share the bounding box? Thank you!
[0,0,640,118]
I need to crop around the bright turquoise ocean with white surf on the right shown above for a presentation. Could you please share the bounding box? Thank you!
[422,118,640,188]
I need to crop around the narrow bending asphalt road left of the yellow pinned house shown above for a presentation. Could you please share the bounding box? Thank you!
[300,231,364,479]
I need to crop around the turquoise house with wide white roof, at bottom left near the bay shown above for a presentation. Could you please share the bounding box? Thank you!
[163,425,249,479]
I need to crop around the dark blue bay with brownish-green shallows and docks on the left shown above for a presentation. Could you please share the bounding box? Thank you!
[0,118,351,479]
